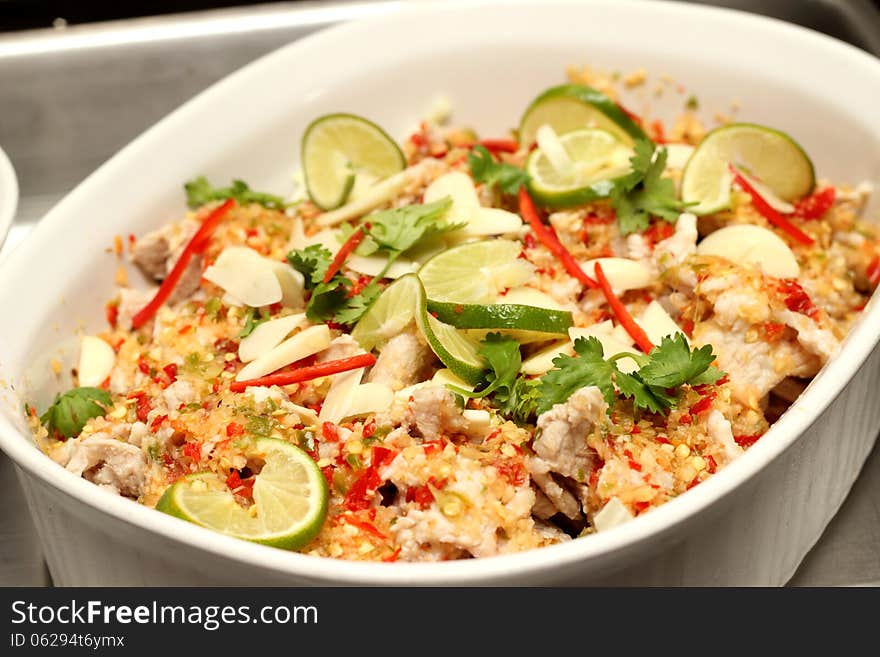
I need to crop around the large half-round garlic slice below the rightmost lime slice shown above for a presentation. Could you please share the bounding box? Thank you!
[697,224,800,278]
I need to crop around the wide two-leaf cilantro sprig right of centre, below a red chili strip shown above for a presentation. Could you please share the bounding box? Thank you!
[537,333,723,414]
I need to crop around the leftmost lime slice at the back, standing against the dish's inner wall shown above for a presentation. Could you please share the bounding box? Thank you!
[302,114,406,210]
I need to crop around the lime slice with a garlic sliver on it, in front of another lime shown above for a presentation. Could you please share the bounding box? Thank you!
[526,128,633,208]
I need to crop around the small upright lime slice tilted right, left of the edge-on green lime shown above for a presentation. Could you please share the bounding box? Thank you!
[351,275,422,351]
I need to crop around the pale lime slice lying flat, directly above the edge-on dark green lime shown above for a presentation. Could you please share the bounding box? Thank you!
[418,239,534,304]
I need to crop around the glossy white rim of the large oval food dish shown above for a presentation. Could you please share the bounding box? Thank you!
[0,0,880,585]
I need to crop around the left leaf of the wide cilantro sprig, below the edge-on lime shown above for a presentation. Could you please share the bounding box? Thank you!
[537,337,617,415]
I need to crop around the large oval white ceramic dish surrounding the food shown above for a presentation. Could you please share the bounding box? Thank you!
[0,0,880,585]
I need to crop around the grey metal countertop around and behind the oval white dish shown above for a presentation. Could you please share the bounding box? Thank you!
[0,0,880,586]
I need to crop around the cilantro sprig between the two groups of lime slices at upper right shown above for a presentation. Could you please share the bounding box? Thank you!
[611,139,686,235]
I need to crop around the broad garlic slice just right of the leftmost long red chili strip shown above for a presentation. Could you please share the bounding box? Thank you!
[202,246,282,308]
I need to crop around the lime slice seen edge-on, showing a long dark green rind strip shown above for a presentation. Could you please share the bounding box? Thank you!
[428,299,573,340]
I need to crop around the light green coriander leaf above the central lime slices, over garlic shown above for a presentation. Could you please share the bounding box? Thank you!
[363,198,462,263]
